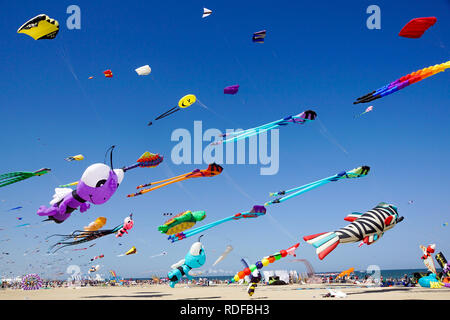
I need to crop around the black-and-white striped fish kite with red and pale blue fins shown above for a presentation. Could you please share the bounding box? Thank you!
[303,202,404,260]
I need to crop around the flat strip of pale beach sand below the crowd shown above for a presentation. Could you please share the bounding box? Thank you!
[0,284,450,301]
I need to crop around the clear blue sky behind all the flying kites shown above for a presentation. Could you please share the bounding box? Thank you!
[0,0,450,277]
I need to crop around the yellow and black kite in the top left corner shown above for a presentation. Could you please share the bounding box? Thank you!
[17,14,59,40]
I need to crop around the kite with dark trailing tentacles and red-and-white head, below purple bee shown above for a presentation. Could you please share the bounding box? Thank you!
[46,214,133,252]
